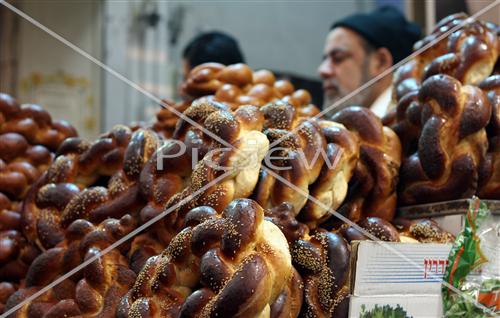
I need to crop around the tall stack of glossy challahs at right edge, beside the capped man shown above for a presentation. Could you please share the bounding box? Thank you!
[385,14,500,205]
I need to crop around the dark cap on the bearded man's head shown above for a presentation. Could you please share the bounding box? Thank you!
[331,6,422,64]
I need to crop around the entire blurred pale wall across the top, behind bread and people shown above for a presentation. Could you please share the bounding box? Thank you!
[0,0,500,137]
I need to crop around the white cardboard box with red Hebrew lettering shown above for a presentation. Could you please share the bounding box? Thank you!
[349,241,451,318]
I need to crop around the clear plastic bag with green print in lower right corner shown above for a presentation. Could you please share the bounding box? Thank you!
[442,198,500,318]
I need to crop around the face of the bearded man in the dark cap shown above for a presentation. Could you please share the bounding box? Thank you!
[318,27,371,112]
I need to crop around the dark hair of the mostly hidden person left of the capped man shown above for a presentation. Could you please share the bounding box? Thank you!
[182,31,245,78]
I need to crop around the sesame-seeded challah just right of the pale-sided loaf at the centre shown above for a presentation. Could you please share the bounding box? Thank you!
[254,101,326,214]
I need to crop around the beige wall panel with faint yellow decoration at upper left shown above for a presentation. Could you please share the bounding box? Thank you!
[0,0,103,137]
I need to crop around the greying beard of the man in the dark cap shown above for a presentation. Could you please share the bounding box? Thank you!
[323,65,371,118]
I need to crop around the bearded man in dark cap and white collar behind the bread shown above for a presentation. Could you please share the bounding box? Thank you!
[318,7,421,117]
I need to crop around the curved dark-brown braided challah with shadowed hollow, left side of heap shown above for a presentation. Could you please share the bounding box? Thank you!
[23,126,158,249]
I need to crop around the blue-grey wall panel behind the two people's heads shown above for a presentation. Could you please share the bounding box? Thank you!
[104,0,375,132]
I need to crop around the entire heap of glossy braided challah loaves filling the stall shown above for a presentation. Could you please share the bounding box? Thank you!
[0,12,500,318]
